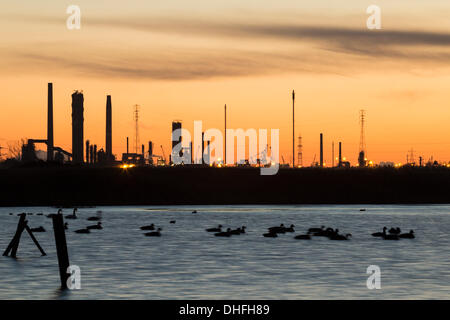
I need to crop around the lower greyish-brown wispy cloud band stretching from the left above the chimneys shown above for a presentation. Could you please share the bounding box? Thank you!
[1,49,332,80]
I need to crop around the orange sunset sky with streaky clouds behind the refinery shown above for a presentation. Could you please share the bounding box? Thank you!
[0,0,450,165]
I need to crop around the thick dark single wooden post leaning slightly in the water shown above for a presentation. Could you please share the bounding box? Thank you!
[52,214,70,289]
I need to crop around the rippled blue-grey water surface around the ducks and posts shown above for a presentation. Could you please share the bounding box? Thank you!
[0,205,450,299]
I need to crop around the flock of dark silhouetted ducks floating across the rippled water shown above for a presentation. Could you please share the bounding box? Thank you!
[6,208,415,240]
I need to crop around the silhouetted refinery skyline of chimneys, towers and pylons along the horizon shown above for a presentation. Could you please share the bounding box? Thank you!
[7,83,449,168]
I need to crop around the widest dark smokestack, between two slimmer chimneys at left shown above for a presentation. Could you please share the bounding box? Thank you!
[72,91,84,164]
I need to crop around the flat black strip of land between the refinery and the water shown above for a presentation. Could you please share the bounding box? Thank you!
[0,166,450,206]
